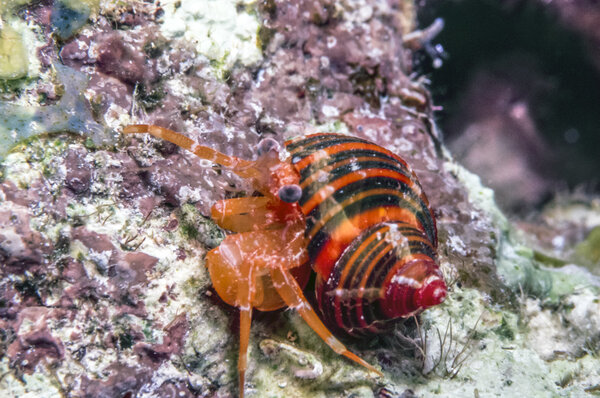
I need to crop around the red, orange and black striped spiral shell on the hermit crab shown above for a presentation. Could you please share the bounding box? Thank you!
[285,134,446,335]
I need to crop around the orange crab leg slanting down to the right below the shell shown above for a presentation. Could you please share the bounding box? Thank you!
[271,266,382,376]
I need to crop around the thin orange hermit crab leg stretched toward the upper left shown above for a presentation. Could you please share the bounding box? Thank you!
[123,124,257,178]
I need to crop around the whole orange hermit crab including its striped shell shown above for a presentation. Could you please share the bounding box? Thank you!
[124,125,446,396]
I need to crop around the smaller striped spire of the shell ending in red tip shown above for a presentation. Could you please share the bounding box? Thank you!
[317,221,445,335]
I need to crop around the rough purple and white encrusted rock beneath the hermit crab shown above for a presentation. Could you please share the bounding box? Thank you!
[0,0,600,397]
